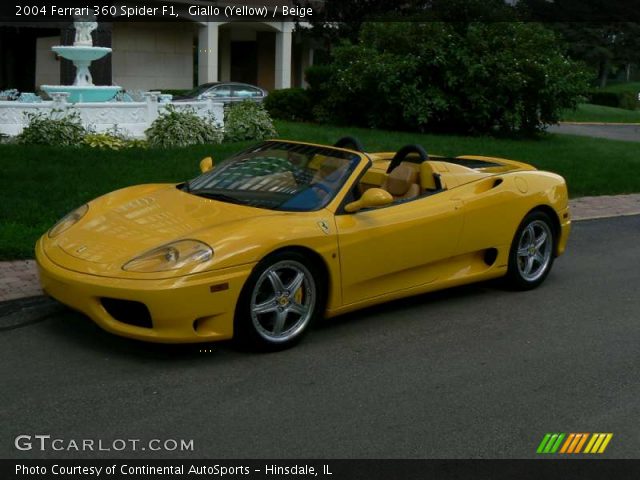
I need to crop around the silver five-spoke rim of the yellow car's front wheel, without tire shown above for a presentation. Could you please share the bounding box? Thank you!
[249,260,317,343]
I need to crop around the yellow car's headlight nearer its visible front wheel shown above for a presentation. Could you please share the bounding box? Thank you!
[122,240,213,273]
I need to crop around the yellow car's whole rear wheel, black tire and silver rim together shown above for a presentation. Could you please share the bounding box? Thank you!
[506,210,557,290]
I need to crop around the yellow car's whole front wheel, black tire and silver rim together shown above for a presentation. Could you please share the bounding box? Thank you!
[234,251,326,351]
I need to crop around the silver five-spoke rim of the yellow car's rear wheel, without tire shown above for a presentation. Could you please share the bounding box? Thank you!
[517,220,553,282]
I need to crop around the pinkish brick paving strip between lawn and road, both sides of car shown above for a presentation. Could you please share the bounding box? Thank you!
[0,193,640,302]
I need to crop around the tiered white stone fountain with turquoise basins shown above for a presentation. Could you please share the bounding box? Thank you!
[40,18,121,103]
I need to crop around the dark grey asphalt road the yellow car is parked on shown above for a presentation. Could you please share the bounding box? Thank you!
[0,216,640,458]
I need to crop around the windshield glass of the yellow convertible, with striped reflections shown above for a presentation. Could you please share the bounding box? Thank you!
[188,142,360,211]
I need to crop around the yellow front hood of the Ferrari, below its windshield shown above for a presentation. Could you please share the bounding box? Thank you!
[48,185,279,273]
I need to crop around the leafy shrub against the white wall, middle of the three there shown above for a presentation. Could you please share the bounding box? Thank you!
[145,105,222,148]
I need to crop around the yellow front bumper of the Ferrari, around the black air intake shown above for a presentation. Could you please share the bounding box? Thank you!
[36,241,254,343]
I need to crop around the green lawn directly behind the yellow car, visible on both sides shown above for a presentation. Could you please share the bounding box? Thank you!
[0,122,640,260]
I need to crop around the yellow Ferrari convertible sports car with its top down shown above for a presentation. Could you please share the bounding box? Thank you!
[36,137,570,350]
